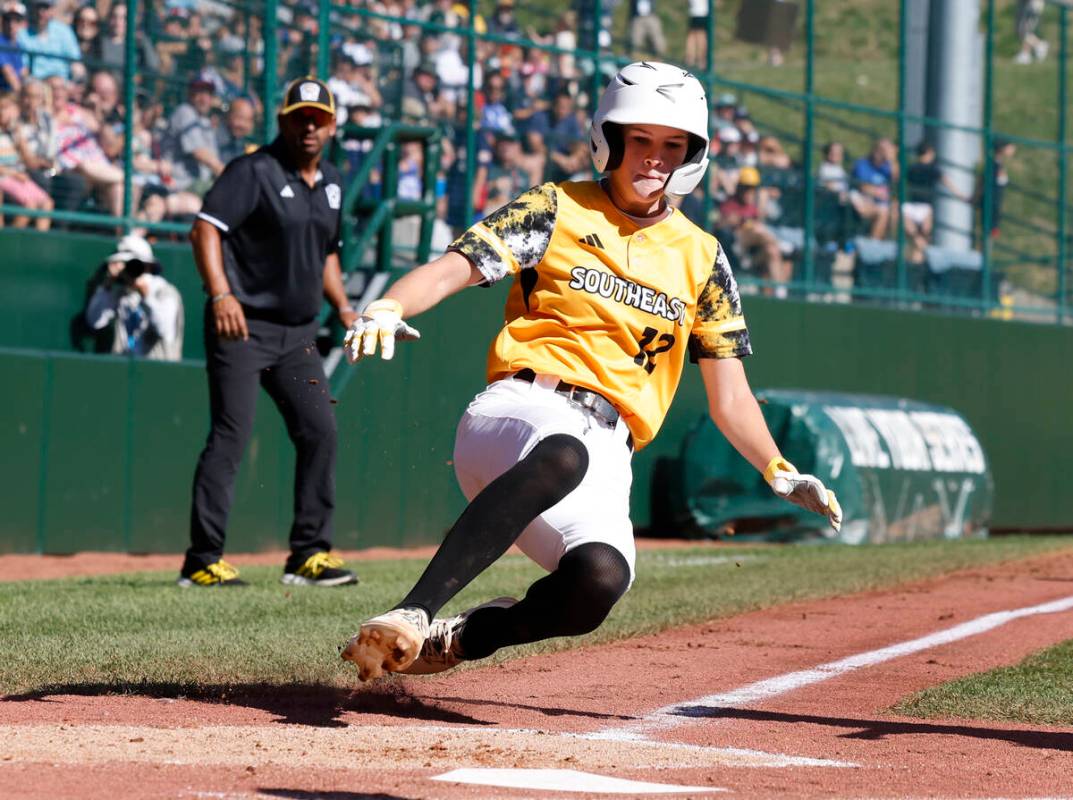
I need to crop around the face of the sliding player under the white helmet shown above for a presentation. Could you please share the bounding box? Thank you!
[611,124,689,217]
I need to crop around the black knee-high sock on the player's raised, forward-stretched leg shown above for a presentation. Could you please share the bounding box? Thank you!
[396,433,589,619]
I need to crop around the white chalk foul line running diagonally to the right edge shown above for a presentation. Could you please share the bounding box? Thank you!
[589,596,1073,741]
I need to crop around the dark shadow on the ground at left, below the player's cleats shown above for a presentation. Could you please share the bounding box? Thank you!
[0,683,488,724]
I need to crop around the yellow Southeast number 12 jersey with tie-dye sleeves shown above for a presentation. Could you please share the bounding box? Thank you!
[450,181,752,449]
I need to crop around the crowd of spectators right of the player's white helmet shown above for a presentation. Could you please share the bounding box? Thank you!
[680,84,995,295]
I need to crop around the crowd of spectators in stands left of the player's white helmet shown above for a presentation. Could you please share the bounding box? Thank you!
[0,0,588,227]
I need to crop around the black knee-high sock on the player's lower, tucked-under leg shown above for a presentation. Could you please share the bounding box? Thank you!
[459,542,630,658]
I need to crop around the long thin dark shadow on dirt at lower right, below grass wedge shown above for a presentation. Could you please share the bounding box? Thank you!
[679,706,1073,752]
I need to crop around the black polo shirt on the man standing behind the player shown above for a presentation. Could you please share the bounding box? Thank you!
[197,138,342,325]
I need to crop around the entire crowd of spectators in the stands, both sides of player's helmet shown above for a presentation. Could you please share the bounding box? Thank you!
[0,0,995,295]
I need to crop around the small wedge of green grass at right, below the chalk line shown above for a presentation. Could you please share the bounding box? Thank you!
[894,639,1073,725]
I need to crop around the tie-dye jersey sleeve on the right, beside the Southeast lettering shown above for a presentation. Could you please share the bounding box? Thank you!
[689,245,752,361]
